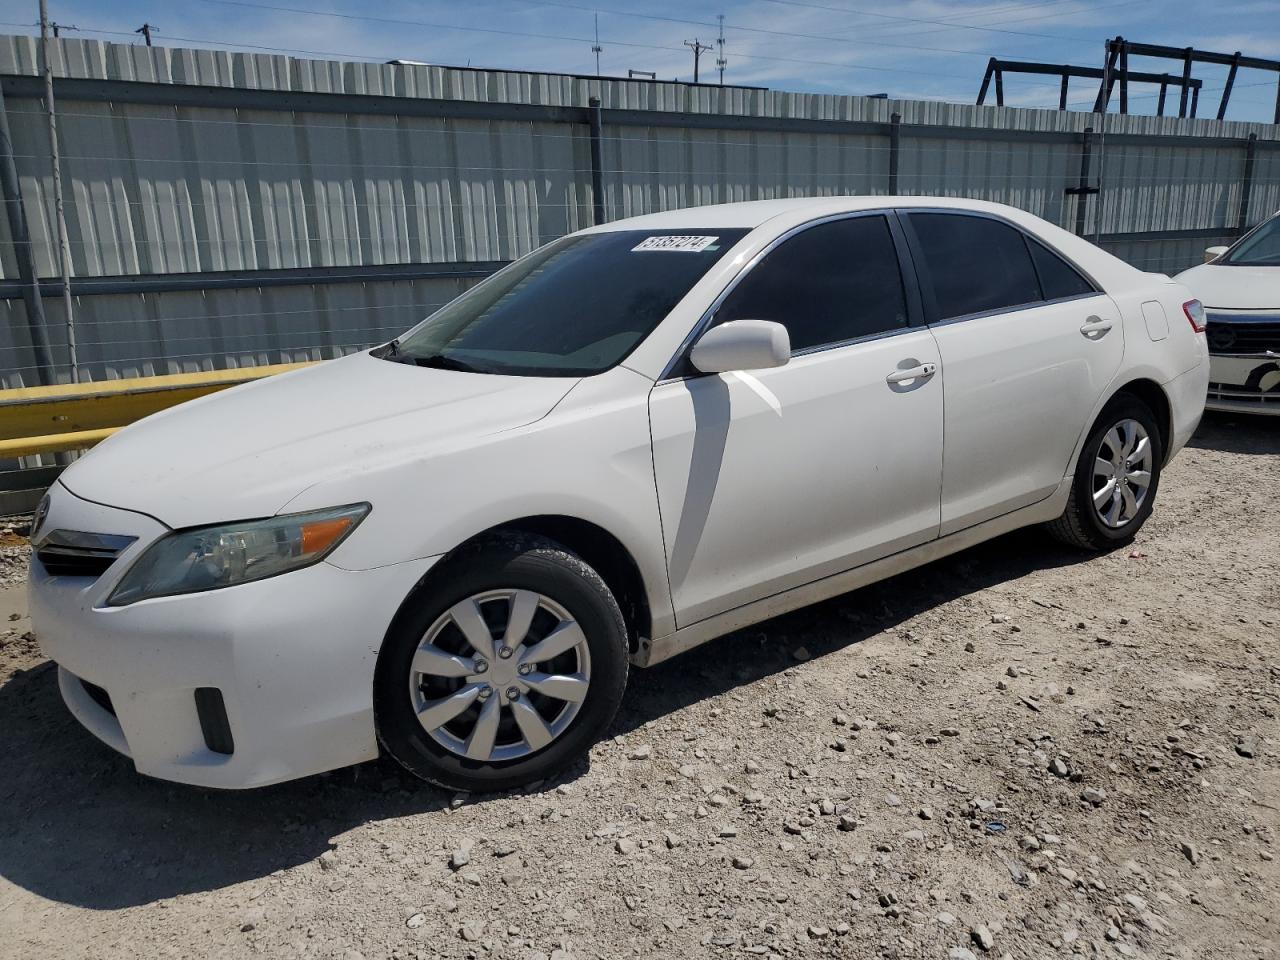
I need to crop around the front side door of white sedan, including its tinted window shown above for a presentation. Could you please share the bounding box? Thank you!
[649,212,942,626]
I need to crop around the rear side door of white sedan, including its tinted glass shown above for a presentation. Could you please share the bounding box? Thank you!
[901,210,1124,535]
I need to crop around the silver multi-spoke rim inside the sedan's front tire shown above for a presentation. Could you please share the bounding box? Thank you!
[410,589,591,763]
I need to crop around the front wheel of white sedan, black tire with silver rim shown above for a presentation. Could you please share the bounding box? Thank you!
[374,534,628,792]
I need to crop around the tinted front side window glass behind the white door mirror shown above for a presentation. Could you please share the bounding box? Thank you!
[716,216,906,351]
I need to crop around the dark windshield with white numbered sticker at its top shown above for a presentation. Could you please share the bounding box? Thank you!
[389,229,746,376]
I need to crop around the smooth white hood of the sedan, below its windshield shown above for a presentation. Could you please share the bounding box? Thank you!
[61,353,577,527]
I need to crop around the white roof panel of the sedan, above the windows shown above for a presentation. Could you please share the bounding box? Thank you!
[584,196,1034,233]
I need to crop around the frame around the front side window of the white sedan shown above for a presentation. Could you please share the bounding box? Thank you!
[655,207,928,385]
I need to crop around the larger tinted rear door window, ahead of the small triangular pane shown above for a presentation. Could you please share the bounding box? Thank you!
[908,214,1041,320]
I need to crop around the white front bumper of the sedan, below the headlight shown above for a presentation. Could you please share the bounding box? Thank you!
[29,484,434,787]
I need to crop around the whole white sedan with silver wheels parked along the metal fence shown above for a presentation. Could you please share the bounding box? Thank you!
[31,197,1208,790]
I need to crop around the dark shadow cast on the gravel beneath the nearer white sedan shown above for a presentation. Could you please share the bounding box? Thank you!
[0,522,1087,910]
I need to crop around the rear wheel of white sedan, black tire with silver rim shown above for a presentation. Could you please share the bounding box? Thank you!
[1048,393,1165,552]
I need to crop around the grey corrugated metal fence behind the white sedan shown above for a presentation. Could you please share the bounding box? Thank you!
[0,36,1280,388]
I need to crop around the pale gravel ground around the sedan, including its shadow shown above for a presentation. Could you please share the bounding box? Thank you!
[0,416,1280,960]
